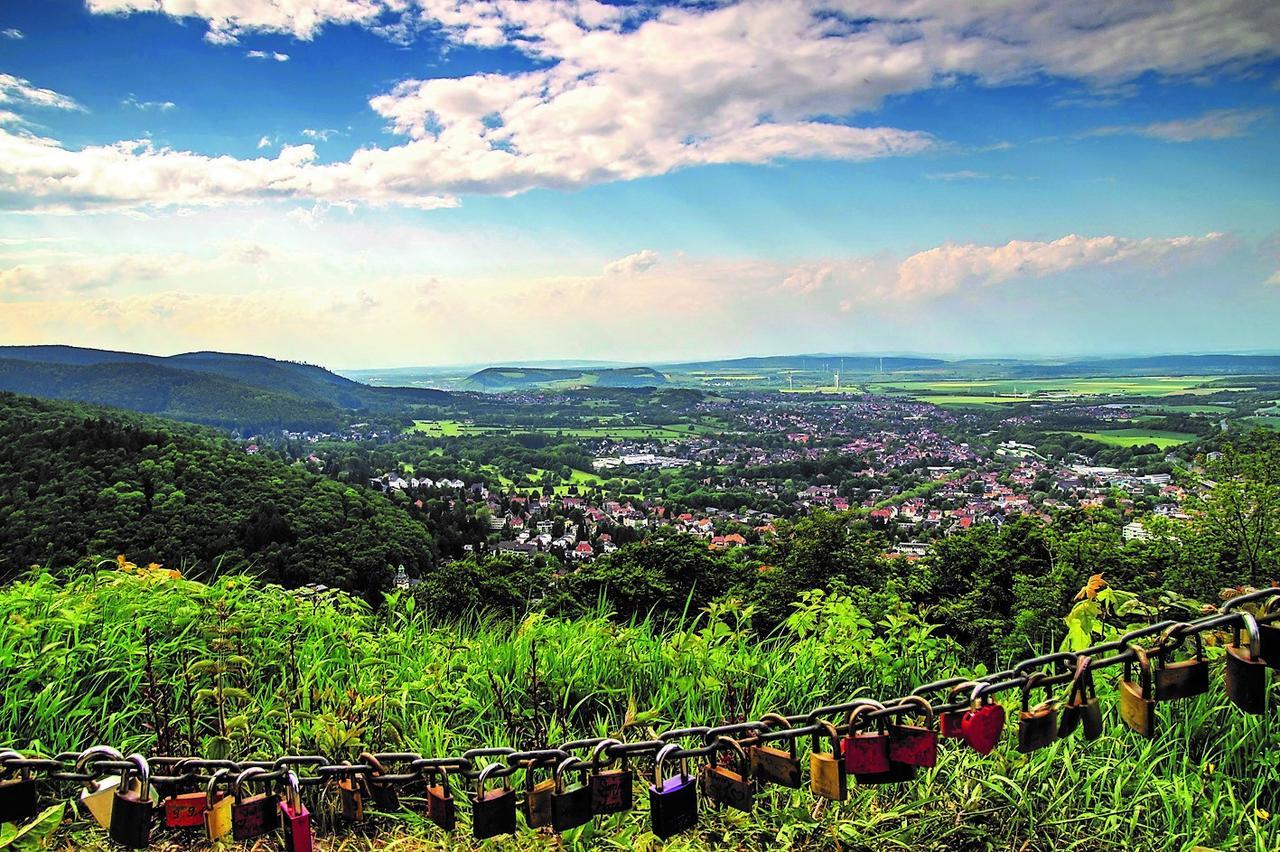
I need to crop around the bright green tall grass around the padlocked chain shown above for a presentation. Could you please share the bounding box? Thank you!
[0,564,1280,849]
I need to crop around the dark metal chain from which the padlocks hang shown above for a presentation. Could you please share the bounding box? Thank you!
[0,587,1280,791]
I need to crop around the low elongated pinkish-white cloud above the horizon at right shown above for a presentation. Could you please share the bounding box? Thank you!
[896,233,1228,297]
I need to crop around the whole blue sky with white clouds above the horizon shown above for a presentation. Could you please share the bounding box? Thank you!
[0,0,1280,368]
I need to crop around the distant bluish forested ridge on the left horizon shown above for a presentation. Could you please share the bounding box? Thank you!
[0,345,449,431]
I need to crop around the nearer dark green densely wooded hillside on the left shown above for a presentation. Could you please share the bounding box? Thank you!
[0,393,434,596]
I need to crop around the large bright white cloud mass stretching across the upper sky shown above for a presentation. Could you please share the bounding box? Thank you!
[15,0,1280,207]
